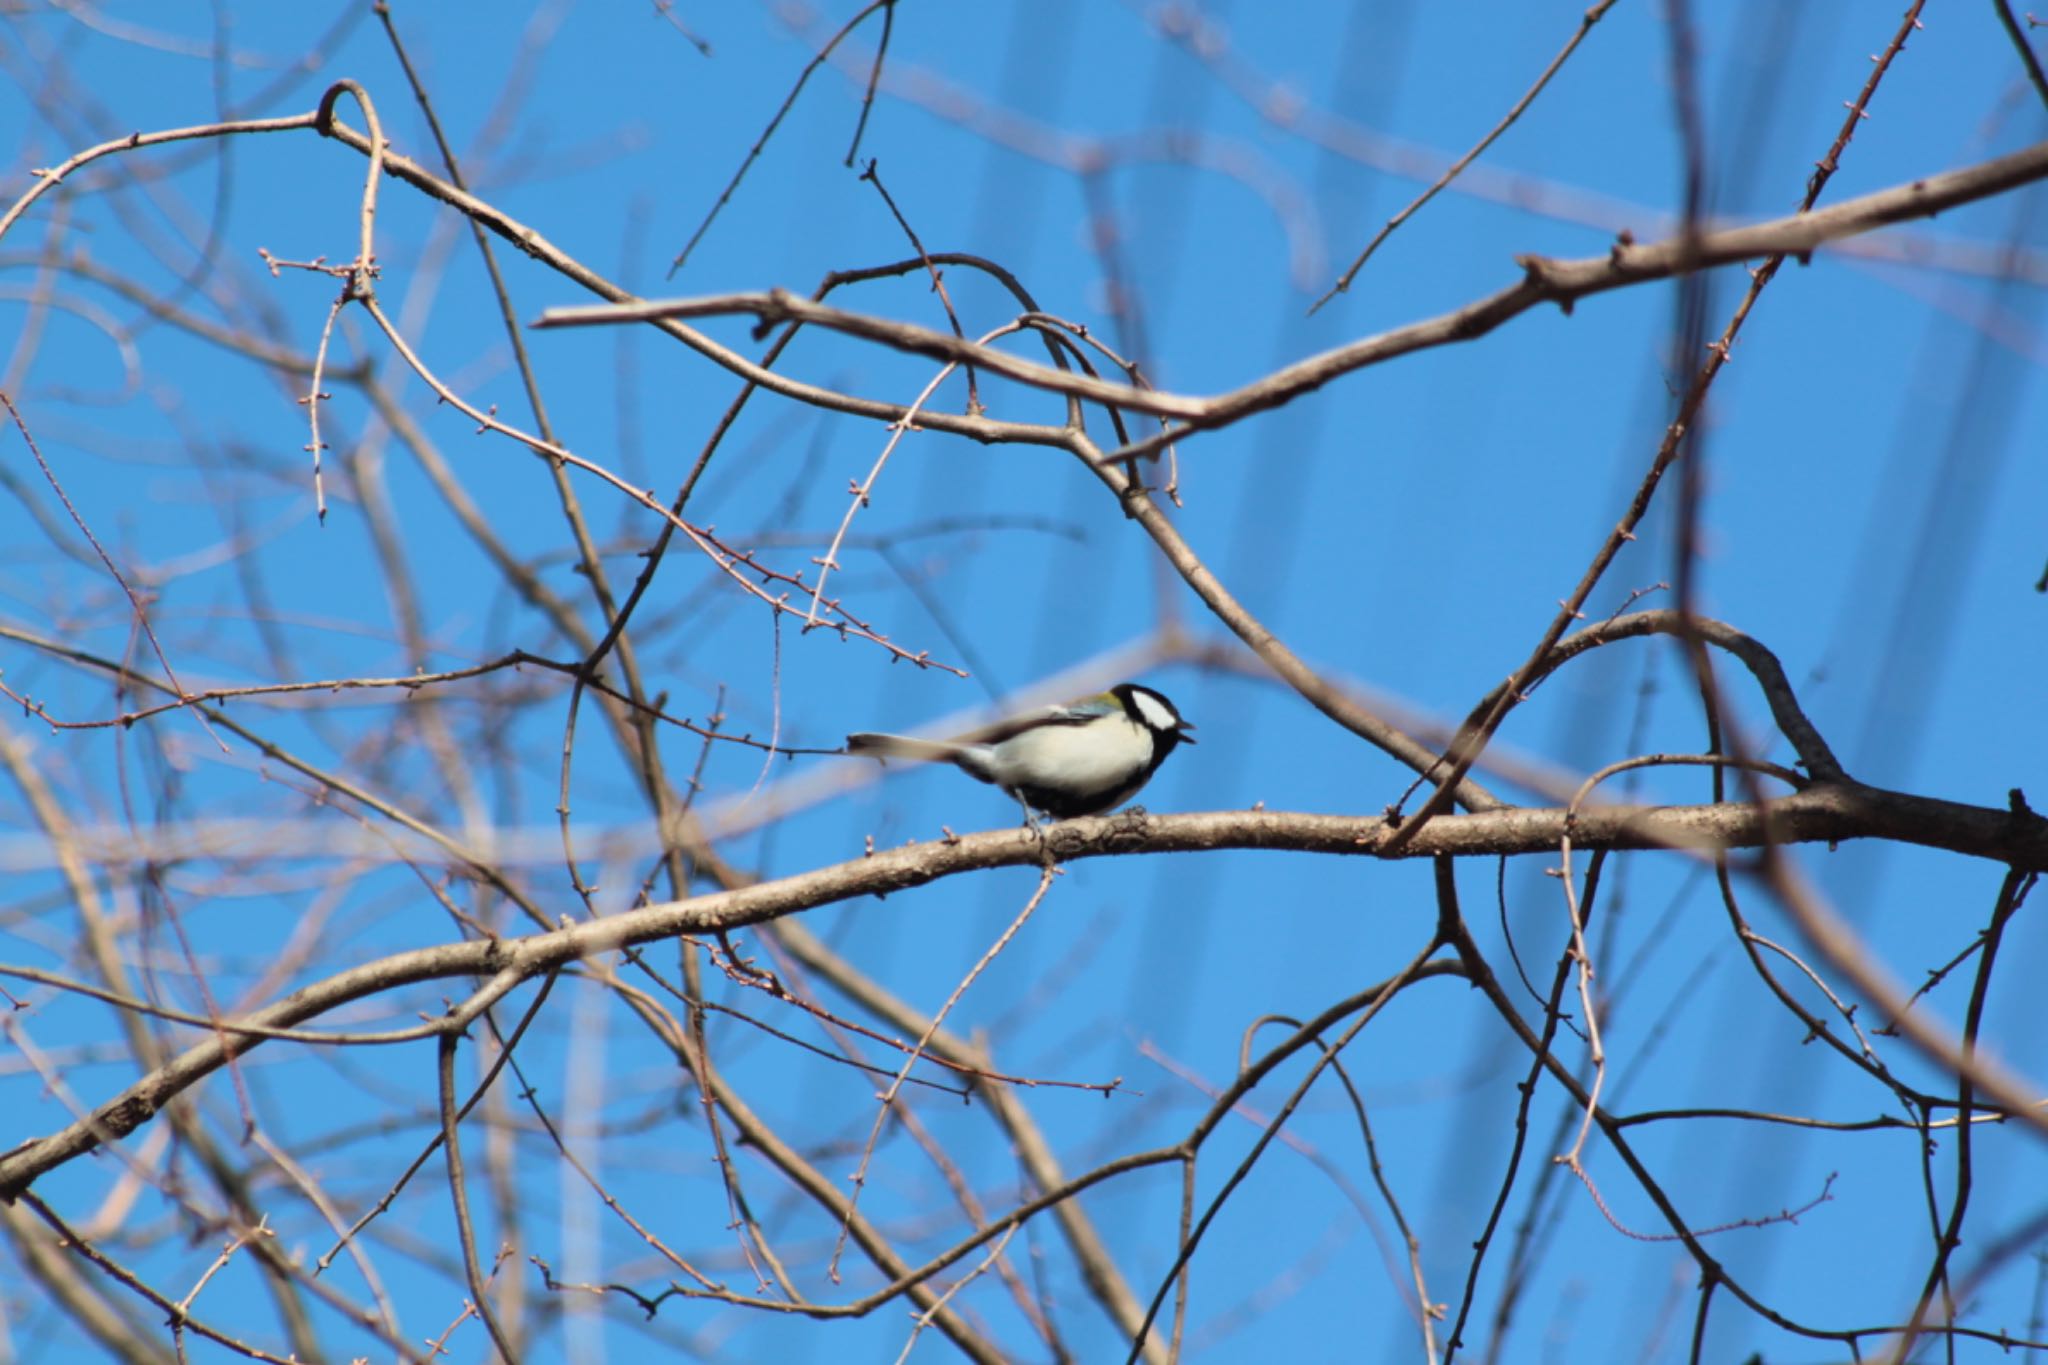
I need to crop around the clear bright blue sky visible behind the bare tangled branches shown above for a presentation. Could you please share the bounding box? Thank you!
[0,0,2048,1361]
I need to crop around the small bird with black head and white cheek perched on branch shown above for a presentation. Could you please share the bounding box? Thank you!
[846,684,1194,821]
